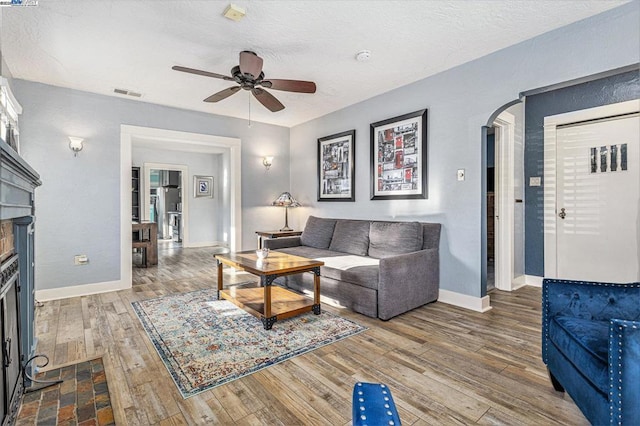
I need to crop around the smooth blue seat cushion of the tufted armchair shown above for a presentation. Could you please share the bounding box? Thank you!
[549,315,609,395]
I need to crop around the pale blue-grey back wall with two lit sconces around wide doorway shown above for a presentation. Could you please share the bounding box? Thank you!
[13,79,289,290]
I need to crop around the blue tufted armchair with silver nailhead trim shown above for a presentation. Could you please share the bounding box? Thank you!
[542,279,640,425]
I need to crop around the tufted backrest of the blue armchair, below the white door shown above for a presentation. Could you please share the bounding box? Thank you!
[542,278,640,363]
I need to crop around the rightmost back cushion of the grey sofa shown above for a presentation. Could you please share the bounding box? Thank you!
[368,222,423,259]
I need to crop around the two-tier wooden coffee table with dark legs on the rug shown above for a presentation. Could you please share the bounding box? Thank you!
[214,251,324,330]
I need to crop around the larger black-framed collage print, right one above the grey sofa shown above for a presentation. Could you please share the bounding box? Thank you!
[371,109,427,200]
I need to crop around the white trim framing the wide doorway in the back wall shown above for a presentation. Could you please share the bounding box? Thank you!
[120,124,242,288]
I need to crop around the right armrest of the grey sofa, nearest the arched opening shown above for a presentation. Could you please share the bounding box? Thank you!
[378,249,440,320]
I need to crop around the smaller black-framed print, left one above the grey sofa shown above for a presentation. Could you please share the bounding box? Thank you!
[318,130,356,201]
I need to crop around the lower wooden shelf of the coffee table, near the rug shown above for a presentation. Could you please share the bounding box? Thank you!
[220,285,320,330]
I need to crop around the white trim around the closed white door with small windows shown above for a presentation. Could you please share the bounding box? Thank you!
[543,99,640,278]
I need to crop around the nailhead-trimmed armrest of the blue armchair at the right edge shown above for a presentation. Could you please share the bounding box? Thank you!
[609,319,640,424]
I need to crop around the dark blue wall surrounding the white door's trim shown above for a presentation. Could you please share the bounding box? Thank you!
[524,71,640,276]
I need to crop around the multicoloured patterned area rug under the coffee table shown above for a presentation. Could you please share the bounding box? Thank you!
[132,289,367,398]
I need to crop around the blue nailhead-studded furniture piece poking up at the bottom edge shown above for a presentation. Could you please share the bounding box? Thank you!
[352,382,401,426]
